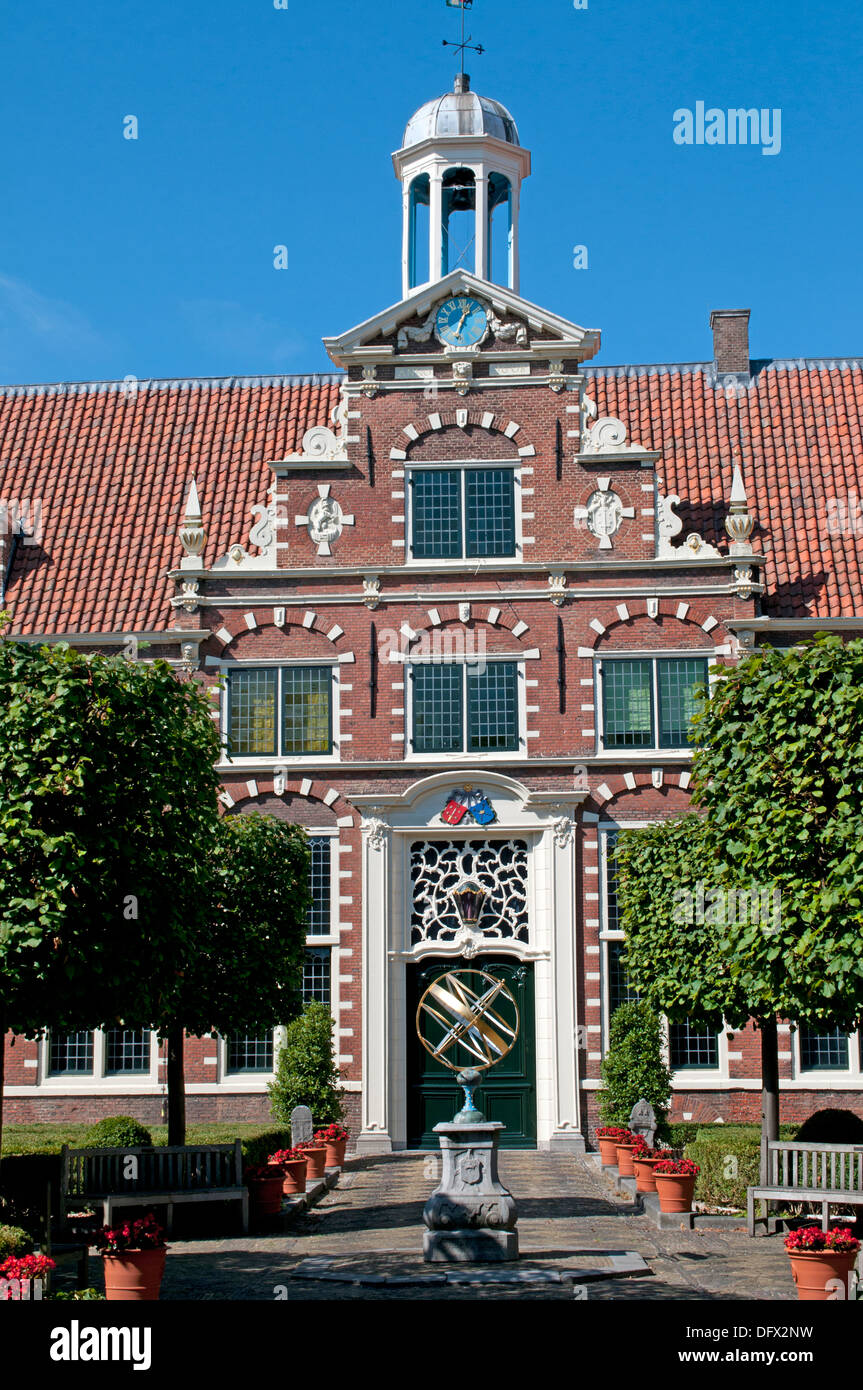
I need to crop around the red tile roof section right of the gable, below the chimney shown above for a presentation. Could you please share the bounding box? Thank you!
[585,359,863,617]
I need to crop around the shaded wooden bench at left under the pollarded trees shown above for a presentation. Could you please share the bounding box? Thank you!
[60,1138,249,1233]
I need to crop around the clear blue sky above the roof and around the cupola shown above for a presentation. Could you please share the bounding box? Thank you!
[0,0,863,382]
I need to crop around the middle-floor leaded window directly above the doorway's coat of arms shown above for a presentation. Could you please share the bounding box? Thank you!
[410,662,518,753]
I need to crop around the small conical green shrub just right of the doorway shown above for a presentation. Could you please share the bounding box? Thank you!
[599,999,671,1126]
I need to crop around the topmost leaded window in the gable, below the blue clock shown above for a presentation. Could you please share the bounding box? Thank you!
[407,467,516,560]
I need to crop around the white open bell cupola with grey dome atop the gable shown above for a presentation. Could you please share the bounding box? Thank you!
[393,72,531,297]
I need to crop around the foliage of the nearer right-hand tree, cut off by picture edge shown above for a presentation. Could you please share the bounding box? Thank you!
[693,634,863,1029]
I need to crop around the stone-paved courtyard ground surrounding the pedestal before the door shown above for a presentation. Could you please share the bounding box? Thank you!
[154,1151,795,1302]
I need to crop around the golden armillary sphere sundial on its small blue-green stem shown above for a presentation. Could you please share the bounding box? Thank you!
[417,970,518,1125]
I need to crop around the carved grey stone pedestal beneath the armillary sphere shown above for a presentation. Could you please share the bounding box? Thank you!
[422,1120,518,1264]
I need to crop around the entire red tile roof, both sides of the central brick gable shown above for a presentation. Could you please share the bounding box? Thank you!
[0,360,863,634]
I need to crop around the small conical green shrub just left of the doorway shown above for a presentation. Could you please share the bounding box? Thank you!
[268,1002,345,1127]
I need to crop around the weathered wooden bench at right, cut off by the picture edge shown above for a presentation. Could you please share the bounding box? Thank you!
[746,1140,863,1236]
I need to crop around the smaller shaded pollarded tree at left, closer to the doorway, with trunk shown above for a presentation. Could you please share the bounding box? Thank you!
[160,815,311,1144]
